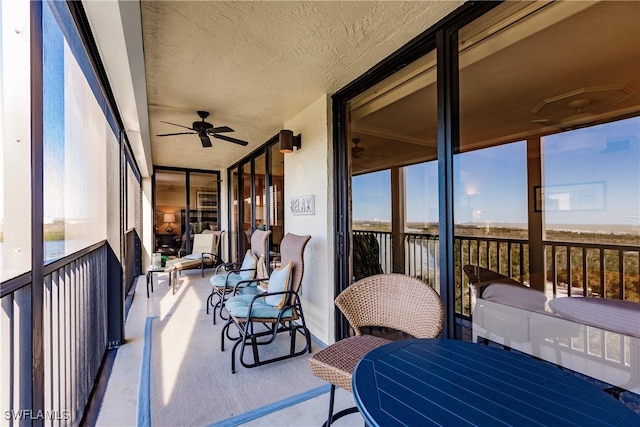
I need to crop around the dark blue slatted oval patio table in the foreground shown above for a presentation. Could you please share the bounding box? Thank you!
[353,339,640,427]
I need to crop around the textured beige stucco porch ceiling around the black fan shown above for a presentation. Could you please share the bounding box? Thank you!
[141,1,463,170]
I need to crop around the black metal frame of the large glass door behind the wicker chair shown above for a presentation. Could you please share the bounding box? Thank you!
[332,2,501,340]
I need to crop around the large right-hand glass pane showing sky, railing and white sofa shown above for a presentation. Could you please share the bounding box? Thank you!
[454,2,640,389]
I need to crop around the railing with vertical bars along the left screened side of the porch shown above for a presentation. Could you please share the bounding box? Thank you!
[0,242,108,426]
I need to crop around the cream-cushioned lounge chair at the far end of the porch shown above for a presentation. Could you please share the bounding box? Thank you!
[165,230,225,278]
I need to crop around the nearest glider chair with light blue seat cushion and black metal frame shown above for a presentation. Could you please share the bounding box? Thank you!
[220,233,311,373]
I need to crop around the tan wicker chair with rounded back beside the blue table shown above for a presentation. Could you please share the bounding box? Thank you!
[309,274,444,426]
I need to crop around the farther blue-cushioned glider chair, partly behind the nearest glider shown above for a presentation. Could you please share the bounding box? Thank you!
[207,230,271,324]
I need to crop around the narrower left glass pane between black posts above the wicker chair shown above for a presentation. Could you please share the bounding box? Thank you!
[348,52,439,284]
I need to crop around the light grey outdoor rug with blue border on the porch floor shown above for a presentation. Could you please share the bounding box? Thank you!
[138,277,326,426]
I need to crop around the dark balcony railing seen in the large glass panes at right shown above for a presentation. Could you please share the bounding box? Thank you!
[354,231,640,318]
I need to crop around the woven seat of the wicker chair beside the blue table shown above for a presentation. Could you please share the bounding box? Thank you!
[309,335,392,391]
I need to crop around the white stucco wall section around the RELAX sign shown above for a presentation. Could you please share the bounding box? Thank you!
[284,95,334,343]
